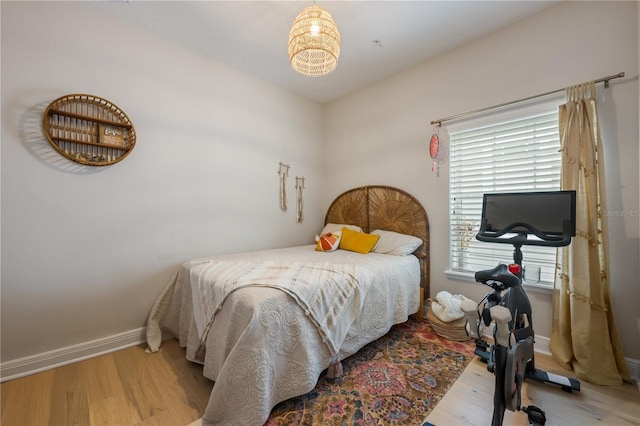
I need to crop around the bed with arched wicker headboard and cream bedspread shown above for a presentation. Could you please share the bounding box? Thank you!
[147,186,429,426]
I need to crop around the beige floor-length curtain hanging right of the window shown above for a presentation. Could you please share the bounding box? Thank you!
[549,82,631,385]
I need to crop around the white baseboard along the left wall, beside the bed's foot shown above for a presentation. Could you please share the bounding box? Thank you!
[0,327,146,382]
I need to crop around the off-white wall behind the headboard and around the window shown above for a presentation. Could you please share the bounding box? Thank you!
[325,2,640,360]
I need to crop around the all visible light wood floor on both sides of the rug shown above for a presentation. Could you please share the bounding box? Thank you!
[0,340,640,426]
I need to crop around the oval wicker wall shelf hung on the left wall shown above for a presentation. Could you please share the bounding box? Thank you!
[42,94,136,166]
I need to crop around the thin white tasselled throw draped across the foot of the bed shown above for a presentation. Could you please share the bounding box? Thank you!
[190,260,373,361]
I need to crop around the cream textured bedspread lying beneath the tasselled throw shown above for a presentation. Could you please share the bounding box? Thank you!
[147,245,420,426]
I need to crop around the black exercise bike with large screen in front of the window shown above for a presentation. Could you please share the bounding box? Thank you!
[460,191,580,426]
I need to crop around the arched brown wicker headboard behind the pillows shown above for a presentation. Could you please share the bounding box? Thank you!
[324,185,430,316]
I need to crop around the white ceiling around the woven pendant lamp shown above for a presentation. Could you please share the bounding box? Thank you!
[88,0,558,103]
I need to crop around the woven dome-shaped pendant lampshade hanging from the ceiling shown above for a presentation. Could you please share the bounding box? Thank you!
[289,5,340,77]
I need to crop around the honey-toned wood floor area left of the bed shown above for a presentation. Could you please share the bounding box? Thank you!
[0,339,213,426]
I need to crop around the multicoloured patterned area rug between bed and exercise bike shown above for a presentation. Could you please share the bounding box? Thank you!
[265,319,475,426]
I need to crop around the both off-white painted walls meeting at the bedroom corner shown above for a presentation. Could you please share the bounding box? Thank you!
[0,2,640,380]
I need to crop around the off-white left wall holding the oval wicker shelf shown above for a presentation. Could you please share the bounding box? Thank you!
[1,2,325,364]
